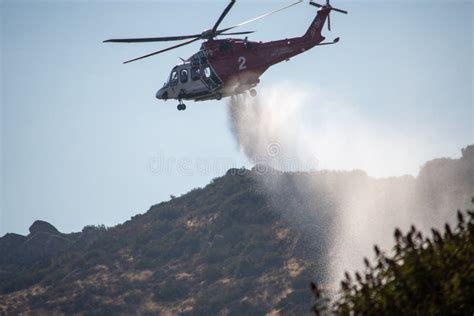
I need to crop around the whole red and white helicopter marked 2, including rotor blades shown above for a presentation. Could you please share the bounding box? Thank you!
[104,0,347,111]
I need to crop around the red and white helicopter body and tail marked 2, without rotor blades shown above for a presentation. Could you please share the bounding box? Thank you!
[156,8,330,101]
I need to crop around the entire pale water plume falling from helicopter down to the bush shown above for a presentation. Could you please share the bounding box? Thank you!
[228,83,474,293]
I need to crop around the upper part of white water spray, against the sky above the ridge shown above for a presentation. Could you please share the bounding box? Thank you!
[228,82,433,177]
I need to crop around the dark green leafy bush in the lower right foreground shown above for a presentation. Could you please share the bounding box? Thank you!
[311,206,474,315]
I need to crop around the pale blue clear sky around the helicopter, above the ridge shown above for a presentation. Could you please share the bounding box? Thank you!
[0,0,474,236]
